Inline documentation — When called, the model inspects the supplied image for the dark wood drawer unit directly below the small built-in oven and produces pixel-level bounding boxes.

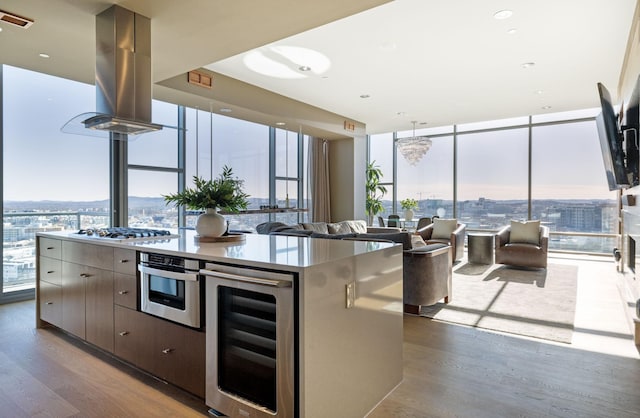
[114,305,205,398]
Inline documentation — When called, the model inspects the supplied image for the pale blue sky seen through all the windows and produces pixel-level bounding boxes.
[3,62,615,201]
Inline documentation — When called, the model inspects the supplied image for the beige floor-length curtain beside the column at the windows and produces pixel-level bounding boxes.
[307,137,331,222]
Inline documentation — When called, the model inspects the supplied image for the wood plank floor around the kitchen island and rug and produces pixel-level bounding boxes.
[0,256,640,418]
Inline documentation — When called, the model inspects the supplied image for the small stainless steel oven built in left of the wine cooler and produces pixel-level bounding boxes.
[138,253,204,329]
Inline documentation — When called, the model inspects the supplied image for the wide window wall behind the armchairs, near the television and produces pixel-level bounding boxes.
[369,109,618,253]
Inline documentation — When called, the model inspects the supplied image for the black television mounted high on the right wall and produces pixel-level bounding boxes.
[596,83,638,190]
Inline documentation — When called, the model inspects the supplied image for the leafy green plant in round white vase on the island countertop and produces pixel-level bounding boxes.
[163,165,249,237]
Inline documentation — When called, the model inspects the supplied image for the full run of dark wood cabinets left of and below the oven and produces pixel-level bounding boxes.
[37,237,206,398]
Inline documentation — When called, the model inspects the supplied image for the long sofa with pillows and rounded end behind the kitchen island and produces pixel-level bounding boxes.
[256,221,453,315]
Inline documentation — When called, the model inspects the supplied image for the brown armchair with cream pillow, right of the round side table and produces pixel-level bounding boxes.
[495,223,549,268]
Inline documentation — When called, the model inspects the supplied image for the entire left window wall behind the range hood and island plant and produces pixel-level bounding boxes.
[0,66,310,303]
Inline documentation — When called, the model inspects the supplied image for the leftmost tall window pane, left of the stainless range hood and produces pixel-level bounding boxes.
[0,65,109,300]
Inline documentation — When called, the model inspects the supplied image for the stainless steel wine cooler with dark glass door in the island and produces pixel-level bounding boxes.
[201,263,296,418]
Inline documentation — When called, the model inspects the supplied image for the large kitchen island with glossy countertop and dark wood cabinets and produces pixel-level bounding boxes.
[37,230,402,417]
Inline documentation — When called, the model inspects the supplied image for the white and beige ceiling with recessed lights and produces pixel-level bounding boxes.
[0,0,636,134]
